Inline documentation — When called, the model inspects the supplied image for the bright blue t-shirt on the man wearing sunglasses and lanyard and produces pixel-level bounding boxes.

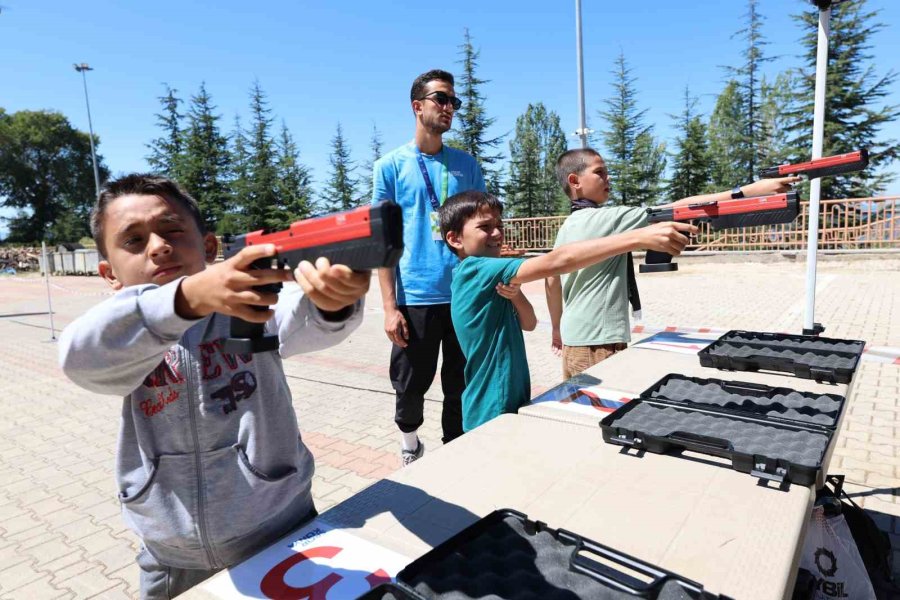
[372,142,485,306]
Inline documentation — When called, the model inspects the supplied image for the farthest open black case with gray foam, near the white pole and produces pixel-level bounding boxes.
[697,330,866,383]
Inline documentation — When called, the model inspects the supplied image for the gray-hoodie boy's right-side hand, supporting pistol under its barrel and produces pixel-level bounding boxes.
[294,257,372,312]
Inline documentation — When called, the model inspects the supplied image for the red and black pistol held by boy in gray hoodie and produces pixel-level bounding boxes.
[223,202,403,354]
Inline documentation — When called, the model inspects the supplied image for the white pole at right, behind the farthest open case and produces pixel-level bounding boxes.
[803,8,831,335]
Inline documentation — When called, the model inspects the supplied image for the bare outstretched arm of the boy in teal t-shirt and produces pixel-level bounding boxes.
[510,223,697,283]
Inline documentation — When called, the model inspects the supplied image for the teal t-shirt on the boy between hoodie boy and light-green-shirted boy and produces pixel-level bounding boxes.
[450,256,531,431]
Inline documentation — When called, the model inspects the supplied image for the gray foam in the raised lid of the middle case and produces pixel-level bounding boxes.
[651,378,841,427]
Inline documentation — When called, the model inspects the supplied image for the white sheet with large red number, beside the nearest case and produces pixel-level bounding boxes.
[202,519,410,600]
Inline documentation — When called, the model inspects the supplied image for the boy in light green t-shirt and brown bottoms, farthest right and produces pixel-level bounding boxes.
[545,148,800,379]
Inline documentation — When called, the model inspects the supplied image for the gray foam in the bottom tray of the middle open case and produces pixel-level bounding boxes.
[610,402,828,467]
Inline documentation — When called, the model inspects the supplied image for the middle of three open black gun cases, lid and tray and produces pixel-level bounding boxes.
[600,374,846,485]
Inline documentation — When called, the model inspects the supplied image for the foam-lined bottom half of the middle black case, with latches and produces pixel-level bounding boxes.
[600,398,836,485]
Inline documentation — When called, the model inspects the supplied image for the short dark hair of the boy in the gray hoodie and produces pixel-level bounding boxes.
[91,173,206,258]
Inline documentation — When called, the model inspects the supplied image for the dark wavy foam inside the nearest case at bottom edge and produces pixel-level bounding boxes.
[405,516,697,600]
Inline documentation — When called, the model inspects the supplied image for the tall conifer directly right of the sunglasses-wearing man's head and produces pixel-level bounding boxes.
[447,29,503,195]
